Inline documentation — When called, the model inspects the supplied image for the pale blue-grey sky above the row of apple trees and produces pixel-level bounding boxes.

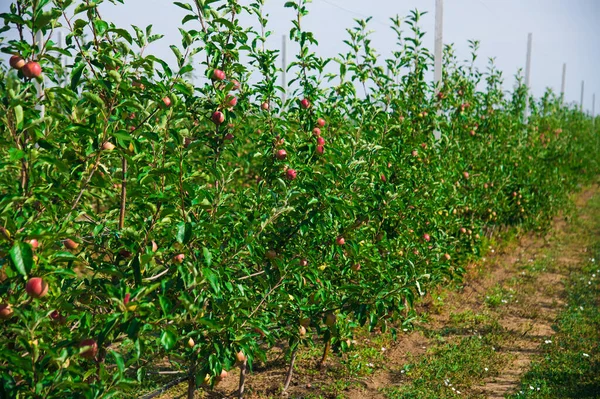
[0,0,600,114]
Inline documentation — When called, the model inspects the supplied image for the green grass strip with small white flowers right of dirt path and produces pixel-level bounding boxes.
[509,246,600,399]
